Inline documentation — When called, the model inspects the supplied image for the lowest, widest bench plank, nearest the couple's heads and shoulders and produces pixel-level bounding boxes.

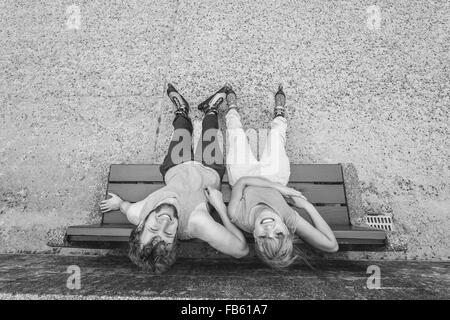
[67,224,386,244]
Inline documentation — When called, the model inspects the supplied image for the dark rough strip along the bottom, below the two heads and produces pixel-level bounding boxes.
[0,255,450,299]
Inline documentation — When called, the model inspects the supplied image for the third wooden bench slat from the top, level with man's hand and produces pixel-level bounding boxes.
[103,206,349,225]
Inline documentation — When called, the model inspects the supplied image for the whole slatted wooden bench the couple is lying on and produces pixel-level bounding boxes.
[65,164,386,248]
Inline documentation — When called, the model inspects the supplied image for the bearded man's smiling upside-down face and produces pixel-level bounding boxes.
[141,208,178,244]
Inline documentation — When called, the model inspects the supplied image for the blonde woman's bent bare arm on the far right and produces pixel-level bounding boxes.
[292,197,339,252]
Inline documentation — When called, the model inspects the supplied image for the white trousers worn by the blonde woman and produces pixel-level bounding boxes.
[225,108,291,186]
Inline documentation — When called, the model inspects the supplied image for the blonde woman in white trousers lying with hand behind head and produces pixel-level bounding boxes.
[226,85,338,269]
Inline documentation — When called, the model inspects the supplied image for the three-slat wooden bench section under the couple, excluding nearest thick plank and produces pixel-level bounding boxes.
[102,164,350,225]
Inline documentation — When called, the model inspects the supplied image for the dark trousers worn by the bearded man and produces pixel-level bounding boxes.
[159,113,225,180]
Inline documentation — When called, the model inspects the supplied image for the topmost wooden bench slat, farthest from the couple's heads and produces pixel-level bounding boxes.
[109,164,343,183]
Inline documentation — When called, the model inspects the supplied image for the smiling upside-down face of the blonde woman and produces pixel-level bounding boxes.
[253,209,289,238]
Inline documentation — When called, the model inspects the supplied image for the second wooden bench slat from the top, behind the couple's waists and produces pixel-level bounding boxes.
[108,183,346,204]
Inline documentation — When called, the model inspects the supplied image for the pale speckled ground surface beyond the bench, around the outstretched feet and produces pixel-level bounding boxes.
[0,0,450,259]
